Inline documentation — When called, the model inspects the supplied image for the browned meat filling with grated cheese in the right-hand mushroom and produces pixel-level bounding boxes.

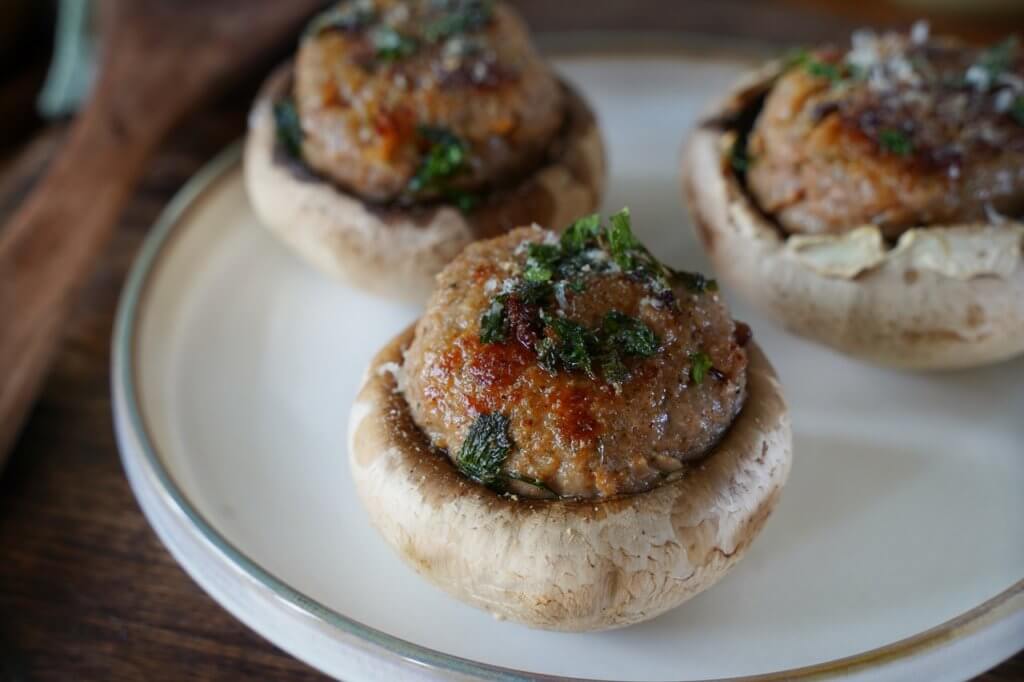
[746,25,1024,238]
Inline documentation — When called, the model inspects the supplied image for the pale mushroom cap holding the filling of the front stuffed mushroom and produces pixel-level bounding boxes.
[349,328,792,632]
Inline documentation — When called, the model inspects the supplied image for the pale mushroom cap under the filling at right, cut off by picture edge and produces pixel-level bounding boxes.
[682,63,1024,370]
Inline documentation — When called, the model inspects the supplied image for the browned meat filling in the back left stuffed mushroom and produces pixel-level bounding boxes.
[279,0,563,203]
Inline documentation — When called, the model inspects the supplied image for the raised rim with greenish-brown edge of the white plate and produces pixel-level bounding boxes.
[111,54,1024,682]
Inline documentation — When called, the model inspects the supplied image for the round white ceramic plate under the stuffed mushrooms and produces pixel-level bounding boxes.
[114,50,1024,680]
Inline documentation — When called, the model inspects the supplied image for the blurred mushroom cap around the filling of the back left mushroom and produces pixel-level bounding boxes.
[244,62,605,302]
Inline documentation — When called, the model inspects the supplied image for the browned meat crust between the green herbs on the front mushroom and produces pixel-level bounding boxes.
[404,227,749,498]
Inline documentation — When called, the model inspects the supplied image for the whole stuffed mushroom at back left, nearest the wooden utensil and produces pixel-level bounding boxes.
[245,0,604,299]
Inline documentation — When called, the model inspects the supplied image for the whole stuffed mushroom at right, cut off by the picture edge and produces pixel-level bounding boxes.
[683,24,1024,369]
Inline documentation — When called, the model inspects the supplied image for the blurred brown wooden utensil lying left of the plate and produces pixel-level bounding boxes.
[0,0,318,465]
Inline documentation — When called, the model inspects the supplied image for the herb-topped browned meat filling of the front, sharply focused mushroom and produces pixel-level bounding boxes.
[404,211,750,498]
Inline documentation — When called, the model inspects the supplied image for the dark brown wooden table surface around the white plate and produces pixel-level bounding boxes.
[0,0,1024,682]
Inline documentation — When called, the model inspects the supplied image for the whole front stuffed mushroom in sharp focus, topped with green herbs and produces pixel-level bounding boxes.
[349,211,792,631]
